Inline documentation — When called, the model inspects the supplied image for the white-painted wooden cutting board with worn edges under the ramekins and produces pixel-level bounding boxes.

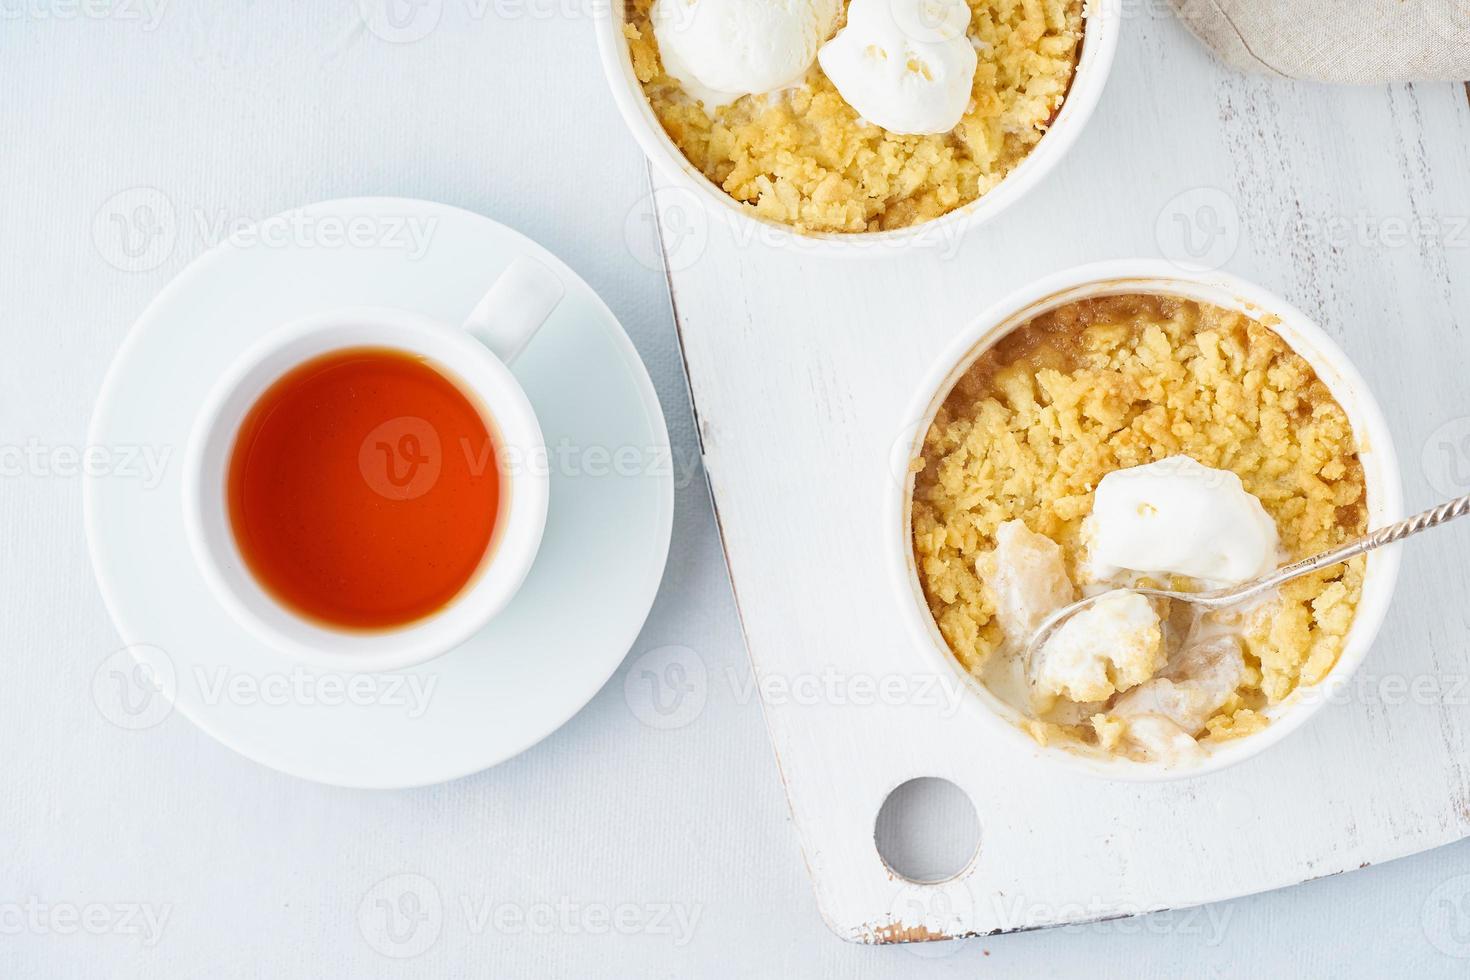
[654,3,1470,942]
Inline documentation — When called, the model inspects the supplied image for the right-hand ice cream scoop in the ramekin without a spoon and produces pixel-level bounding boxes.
[817,0,979,134]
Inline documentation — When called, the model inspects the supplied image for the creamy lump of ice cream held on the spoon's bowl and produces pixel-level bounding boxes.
[1028,591,1169,713]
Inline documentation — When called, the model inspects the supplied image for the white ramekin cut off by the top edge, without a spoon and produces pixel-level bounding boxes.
[592,0,1123,256]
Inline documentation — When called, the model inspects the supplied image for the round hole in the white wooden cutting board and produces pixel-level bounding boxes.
[873,776,980,884]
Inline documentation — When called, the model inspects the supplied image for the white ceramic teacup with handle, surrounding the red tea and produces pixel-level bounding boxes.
[182,257,564,671]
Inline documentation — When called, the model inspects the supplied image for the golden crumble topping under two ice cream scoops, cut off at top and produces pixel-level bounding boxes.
[623,0,1082,232]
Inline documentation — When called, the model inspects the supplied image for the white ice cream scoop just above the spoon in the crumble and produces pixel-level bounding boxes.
[1085,455,1280,585]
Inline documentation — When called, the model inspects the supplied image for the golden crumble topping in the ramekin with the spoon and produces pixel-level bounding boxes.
[913,295,1367,739]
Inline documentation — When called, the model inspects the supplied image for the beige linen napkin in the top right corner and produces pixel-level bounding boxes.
[1173,0,1470,84]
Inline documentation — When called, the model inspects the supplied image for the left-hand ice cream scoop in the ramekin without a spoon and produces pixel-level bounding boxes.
[650,0,841,109]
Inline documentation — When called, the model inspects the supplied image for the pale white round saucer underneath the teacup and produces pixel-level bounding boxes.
[84,198,673,788]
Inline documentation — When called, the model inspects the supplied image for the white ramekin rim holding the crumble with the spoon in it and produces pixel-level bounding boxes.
[885,259,1402,782]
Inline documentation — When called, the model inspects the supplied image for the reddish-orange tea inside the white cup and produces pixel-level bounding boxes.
[226,348,503,629]
